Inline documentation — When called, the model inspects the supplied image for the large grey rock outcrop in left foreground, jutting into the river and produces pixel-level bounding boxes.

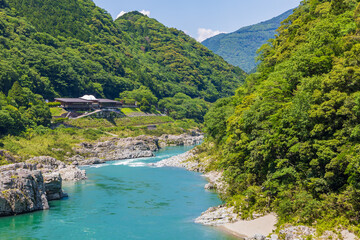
[0,157,86,216]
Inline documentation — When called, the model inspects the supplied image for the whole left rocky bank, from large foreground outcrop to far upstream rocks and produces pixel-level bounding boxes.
[0,133,203,217]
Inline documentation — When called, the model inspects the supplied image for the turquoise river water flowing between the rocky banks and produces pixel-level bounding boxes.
[0,147,238,240]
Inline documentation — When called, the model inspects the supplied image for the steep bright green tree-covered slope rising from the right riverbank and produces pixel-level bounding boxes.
[206,0,360,232]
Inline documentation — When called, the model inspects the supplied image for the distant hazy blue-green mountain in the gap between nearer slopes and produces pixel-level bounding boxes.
[202,9,293,72]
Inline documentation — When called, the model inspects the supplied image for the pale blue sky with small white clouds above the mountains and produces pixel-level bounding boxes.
[94,0,301,41]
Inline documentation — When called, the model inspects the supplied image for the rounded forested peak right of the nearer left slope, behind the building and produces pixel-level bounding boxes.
[116,12,244,101]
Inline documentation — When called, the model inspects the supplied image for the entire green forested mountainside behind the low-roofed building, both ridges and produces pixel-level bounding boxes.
[0,0,244,101]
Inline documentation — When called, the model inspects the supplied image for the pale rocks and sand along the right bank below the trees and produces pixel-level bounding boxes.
[153,150,358,240]
